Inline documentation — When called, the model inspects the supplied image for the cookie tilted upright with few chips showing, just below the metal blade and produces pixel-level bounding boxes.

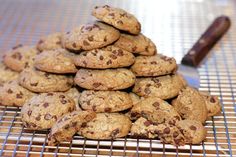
[172,86,207,123]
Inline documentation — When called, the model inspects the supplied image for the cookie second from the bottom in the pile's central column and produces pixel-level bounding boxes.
[79,90,133,112]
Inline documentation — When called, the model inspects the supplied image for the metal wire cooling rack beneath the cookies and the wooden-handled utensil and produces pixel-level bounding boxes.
[0,0,236,157]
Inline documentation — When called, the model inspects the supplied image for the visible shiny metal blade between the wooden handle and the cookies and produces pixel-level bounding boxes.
[178,64,200,89]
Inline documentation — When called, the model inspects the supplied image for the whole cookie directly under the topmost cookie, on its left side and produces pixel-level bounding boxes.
[62,22,120,51]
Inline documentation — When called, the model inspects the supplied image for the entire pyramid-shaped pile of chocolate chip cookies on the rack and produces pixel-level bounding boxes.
[0,5,221,146]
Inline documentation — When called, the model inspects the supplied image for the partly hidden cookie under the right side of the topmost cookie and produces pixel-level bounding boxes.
[114,33,157,56]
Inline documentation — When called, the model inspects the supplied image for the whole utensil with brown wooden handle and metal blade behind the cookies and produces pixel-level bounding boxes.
[178,15,231,88]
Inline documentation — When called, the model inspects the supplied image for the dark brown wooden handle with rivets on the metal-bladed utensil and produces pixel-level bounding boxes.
[181,16,231,67]
